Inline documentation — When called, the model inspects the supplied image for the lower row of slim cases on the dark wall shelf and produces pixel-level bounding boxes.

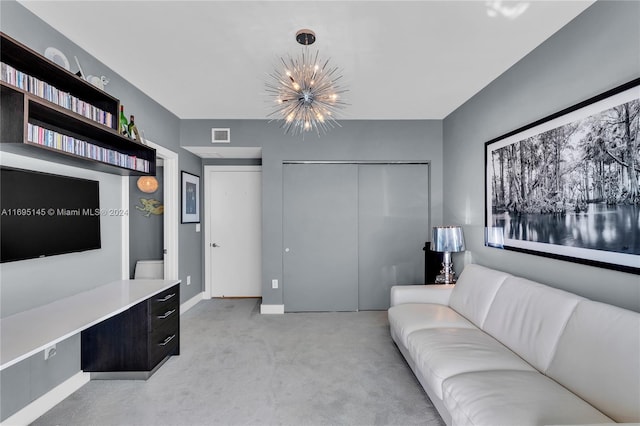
[27,123,149,173]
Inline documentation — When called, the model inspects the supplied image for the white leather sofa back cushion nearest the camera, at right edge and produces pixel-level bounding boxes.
[547,301,640,423]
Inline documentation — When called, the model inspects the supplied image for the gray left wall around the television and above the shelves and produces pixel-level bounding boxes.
[0,0,203,420]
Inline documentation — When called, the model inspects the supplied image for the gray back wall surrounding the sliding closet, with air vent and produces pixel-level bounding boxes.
[180,120,443,305]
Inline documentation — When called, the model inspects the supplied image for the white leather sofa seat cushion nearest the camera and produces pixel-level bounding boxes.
[443,370,612,426]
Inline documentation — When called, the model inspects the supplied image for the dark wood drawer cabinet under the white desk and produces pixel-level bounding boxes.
[81,285,180,379]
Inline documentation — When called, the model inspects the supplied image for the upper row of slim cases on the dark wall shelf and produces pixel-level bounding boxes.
[0,62,114,128]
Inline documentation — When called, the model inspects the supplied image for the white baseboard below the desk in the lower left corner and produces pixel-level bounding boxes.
[0,371,90,426]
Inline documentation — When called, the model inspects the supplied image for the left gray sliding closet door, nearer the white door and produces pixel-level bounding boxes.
[282,164,358,312]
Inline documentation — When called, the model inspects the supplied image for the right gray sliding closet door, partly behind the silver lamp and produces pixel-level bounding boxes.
[358,164,429,310]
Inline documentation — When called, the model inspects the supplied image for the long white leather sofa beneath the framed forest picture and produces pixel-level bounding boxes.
[388,265,640,426]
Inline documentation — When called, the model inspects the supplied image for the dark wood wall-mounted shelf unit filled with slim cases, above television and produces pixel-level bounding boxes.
[0,32,156,176]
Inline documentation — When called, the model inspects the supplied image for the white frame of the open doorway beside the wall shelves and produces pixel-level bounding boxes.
[122,139,180,280]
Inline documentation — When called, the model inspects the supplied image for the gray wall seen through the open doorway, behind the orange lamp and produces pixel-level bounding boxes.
[129,167,164,278]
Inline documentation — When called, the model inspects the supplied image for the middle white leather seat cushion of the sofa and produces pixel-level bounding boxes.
[407,328,536,399]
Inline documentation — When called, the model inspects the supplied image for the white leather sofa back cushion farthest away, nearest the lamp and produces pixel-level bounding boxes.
[449,264,511,328]
